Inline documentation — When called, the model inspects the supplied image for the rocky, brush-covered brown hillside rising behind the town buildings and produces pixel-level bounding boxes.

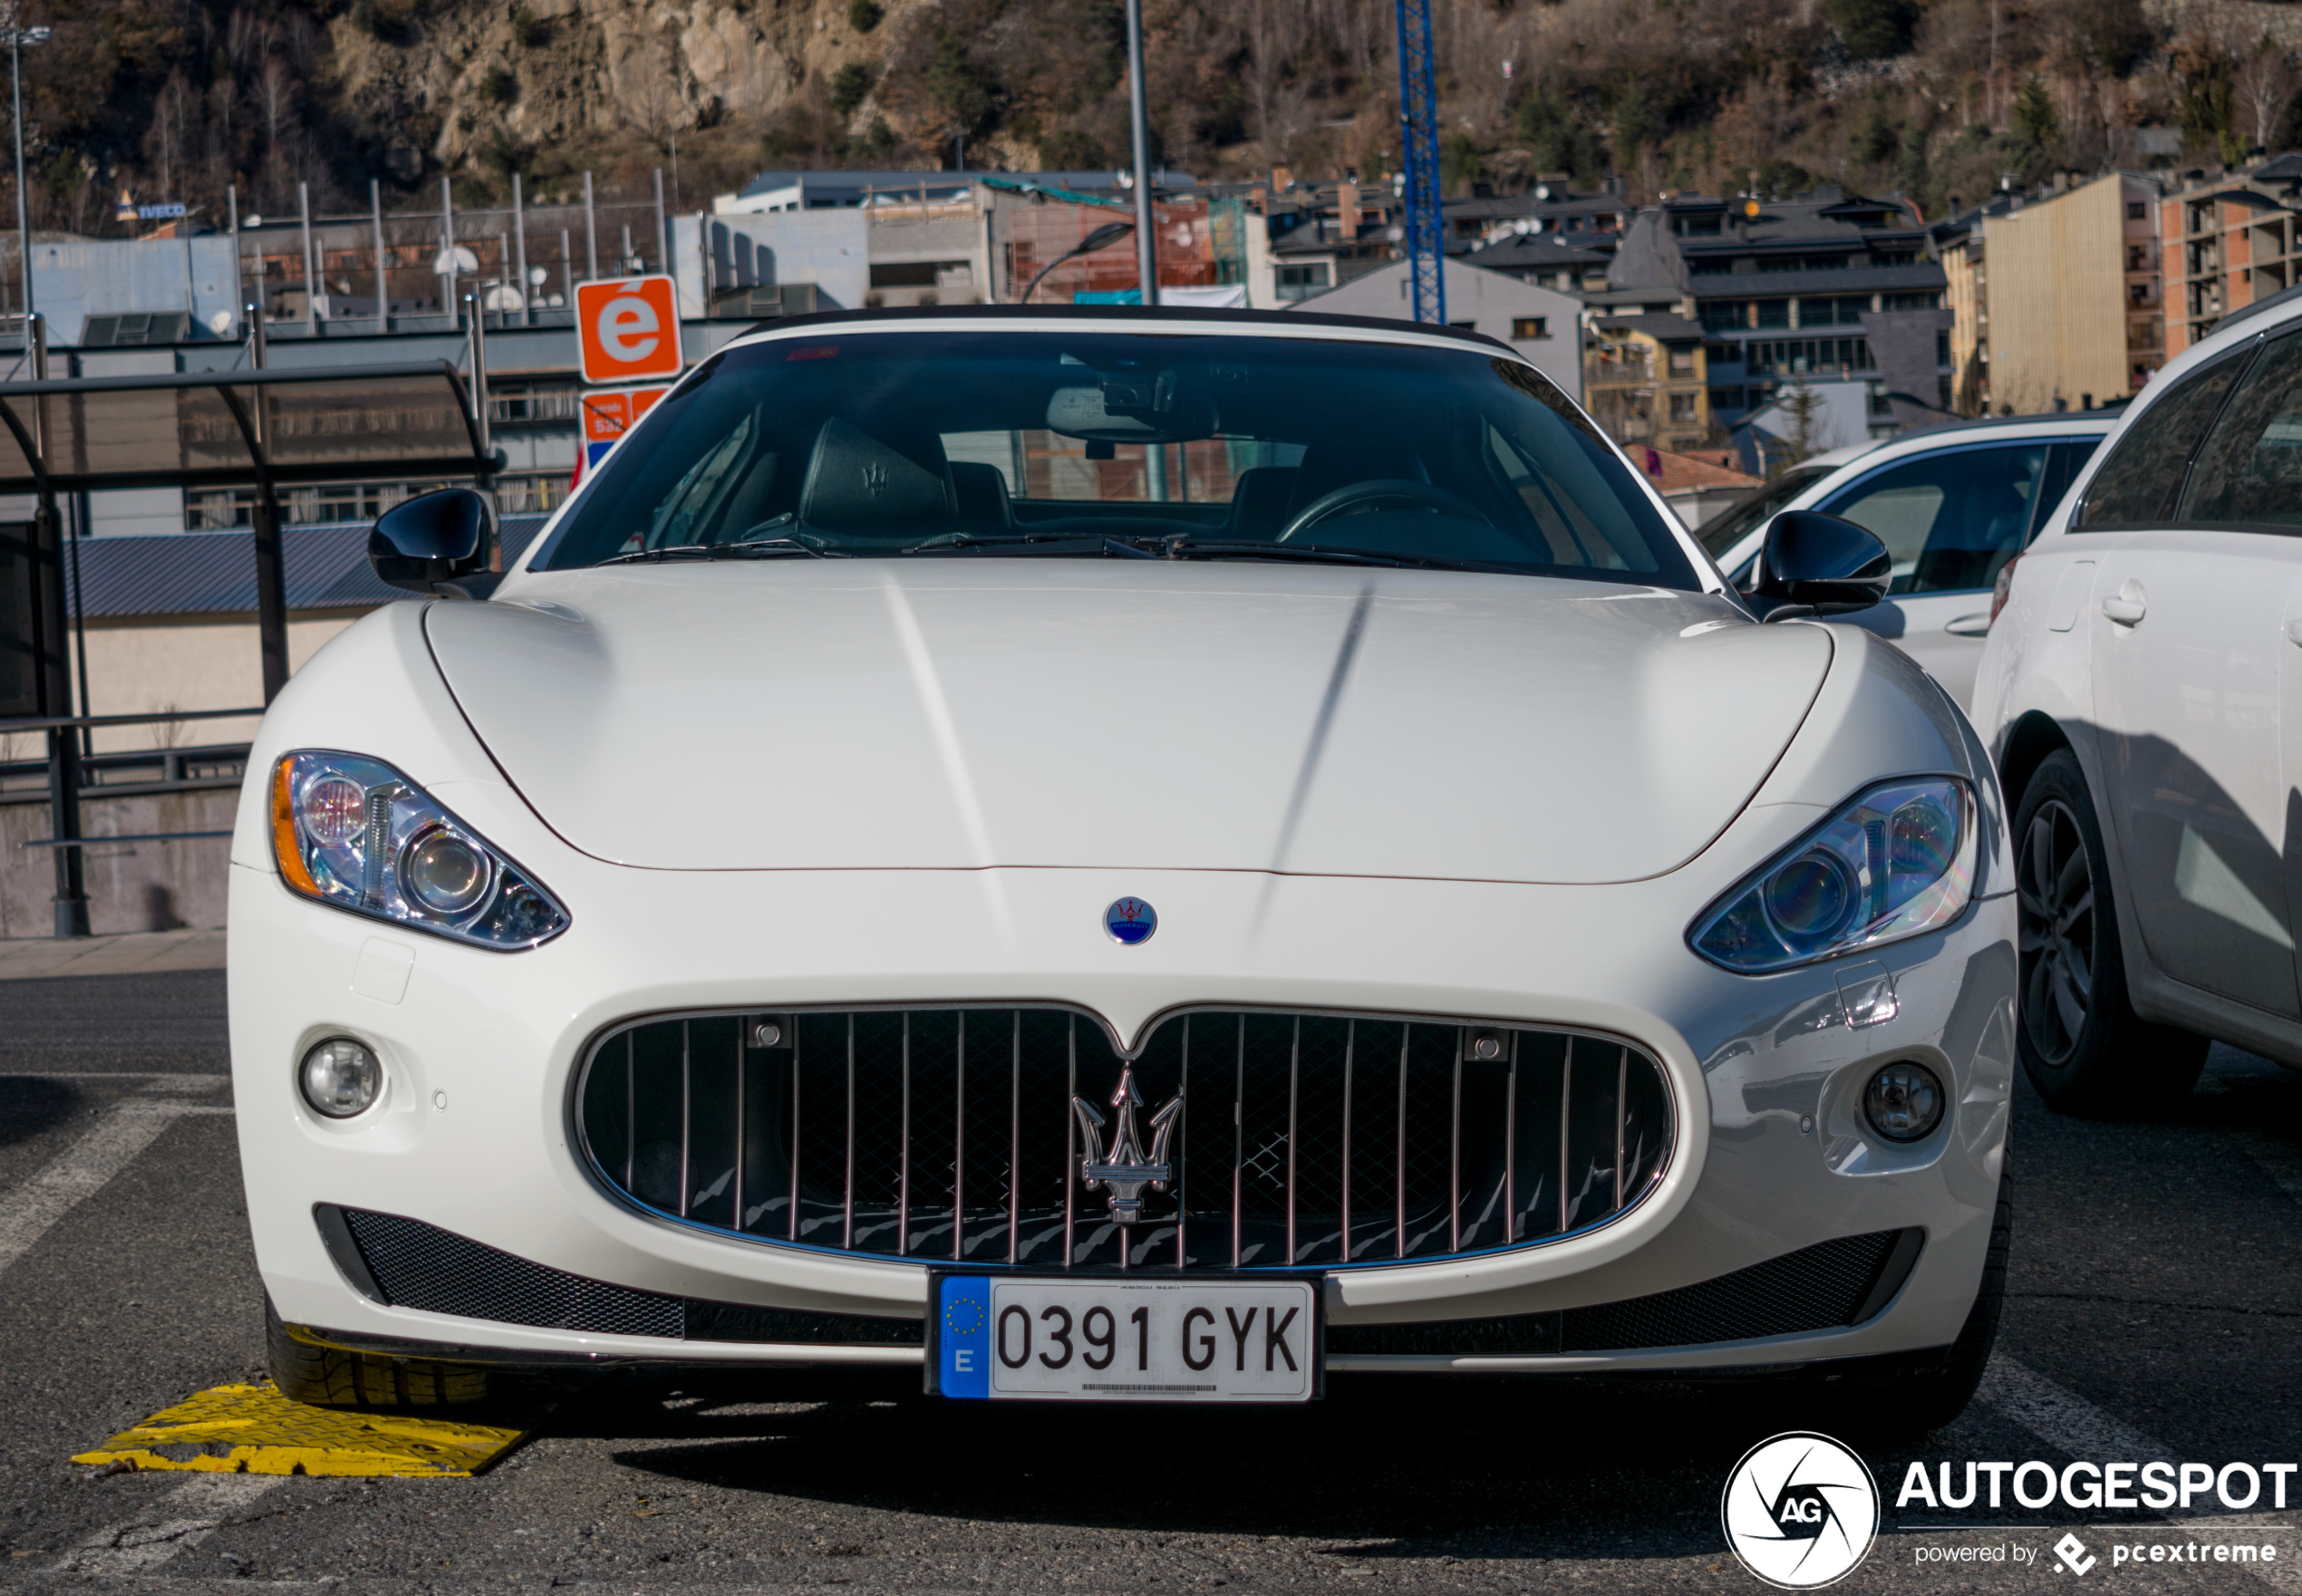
[25,0,2302,233]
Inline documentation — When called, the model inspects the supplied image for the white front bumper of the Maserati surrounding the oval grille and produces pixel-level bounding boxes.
[230,801,2015,1373]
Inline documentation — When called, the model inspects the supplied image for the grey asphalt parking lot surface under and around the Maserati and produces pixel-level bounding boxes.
[0,970,2302,1593]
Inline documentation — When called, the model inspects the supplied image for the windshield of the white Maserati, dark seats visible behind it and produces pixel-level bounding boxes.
[538,327,1699,590]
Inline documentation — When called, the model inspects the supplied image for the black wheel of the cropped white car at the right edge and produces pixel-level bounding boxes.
[2015,749,2210,1119]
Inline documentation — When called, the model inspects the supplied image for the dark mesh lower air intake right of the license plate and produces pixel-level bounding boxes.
[1326,1230,1918,1357]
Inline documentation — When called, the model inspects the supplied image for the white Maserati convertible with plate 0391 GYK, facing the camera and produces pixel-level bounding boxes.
[230,309,2017,1426]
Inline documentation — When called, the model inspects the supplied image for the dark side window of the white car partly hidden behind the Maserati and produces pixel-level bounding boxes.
[1819,444,2046,592]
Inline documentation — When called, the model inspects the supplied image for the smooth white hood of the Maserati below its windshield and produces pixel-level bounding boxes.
[426,557,1833,882]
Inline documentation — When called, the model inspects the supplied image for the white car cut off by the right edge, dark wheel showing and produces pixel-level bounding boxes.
[1975,290,2302,1115]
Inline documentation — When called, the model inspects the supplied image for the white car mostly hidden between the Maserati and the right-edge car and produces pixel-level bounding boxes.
[1697,410,2118,707]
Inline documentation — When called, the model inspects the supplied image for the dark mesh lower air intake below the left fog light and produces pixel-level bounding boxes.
[343,1209,686,1336]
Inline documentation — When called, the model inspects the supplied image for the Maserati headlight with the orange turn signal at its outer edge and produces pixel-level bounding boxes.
[272,750,568,949]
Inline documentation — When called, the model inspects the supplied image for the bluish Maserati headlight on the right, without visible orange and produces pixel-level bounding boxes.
[1688,776,1975,974]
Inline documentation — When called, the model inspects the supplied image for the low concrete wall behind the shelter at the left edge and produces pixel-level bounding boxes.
[0,788,239,937]
